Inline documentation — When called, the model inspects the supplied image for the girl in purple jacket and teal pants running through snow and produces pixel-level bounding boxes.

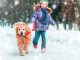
[31,1,55,53]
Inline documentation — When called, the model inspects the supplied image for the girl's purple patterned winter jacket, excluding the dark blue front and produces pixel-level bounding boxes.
[31,10,55,31]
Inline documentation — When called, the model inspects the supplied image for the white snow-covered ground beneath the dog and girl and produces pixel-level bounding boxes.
[0,26,80,60]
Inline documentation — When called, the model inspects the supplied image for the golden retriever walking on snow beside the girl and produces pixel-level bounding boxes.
[16,22,31,56]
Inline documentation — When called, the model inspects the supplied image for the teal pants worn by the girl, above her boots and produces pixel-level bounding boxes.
[33,31,46,48]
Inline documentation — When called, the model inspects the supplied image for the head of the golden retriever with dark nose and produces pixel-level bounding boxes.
[16,22,28,36]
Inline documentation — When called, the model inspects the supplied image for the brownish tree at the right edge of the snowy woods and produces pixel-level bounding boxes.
[62,0,75,29]
